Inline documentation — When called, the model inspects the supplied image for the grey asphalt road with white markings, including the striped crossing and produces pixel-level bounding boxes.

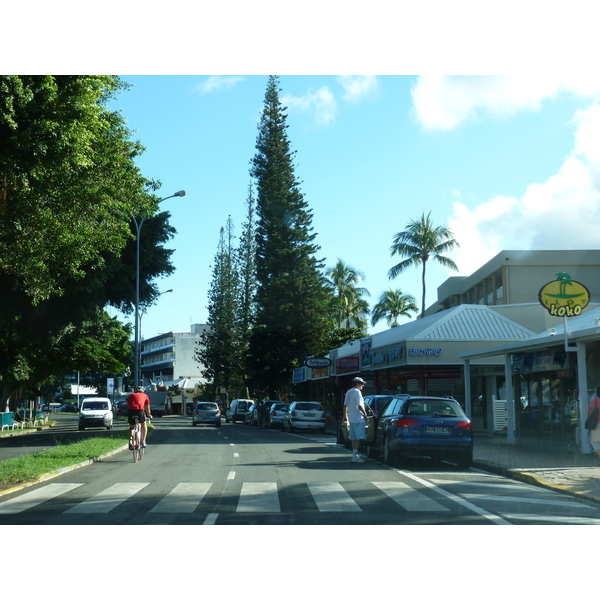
[0,418,600,525]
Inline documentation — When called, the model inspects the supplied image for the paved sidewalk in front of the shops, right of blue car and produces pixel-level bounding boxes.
[473,434,600,503]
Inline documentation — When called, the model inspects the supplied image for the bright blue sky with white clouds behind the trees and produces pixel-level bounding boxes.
[103,74,600,337]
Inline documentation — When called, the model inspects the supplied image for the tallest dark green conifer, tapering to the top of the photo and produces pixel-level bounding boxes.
[248,76,327,397]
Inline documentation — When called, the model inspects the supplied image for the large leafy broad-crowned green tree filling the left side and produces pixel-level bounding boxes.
[0,76,173,410]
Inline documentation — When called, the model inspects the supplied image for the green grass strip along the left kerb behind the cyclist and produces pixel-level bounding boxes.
[0,430,129,485]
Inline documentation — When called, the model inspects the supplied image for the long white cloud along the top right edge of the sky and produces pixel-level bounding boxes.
[411,73,600,130]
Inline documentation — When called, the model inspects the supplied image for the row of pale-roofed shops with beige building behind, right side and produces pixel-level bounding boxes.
[294,250,600,448]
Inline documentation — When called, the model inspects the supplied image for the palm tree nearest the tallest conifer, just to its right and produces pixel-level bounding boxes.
[325,258,371,327]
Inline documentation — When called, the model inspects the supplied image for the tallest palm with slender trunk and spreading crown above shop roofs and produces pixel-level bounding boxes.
[388,213,459,317]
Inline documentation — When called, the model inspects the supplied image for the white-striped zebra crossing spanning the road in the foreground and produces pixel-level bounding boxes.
[0,472,600,525]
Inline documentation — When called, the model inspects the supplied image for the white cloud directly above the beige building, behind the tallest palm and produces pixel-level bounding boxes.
[449,104,600,275]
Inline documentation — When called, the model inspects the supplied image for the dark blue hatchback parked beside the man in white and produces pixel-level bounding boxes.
[369,396,473,468]
